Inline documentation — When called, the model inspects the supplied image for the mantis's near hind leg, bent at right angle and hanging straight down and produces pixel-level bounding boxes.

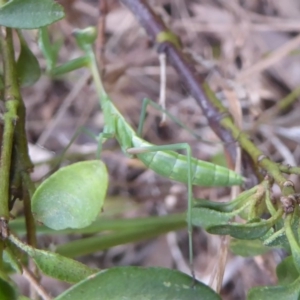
[127,143,195,278]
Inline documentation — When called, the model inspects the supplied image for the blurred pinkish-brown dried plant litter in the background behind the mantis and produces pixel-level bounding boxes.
[23,0,300,300]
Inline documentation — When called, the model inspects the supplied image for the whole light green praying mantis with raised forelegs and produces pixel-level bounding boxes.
[40,27,244,273]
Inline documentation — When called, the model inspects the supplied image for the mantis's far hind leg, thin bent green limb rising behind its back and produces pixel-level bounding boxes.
[137,98,206,143]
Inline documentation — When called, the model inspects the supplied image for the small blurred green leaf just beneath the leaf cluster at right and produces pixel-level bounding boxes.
[230,239,271,257]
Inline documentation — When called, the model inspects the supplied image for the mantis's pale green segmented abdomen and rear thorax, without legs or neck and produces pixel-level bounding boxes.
[100,94,243,186]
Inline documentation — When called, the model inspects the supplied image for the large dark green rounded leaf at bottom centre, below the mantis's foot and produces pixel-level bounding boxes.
[55,267,221,300]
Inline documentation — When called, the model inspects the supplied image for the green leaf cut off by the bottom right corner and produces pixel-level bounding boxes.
[247,278,300,300]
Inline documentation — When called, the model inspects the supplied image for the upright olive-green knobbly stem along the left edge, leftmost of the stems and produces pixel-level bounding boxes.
[0,27,20,220]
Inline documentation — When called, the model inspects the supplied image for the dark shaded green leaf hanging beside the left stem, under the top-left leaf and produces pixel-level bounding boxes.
[17,31,41,86]
